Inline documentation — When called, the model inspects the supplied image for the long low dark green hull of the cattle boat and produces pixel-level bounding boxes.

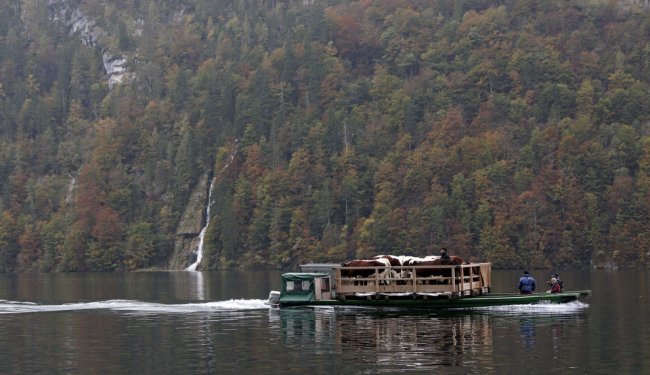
[279,290,591,310]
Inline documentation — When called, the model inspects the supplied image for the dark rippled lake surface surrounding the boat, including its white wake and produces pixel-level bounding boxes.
[0,270,650,374]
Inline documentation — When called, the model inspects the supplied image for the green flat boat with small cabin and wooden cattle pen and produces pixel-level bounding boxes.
[268,263,591,309]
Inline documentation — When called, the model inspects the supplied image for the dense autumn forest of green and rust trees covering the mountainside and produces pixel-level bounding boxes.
[0,0,650,272]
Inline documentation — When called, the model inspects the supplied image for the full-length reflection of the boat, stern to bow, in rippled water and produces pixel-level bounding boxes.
[269,306,584,372]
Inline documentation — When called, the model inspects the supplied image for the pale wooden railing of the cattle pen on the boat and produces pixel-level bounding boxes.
[335,263,491,296]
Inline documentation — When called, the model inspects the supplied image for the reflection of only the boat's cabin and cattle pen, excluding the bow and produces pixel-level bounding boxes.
[269,309,493,369]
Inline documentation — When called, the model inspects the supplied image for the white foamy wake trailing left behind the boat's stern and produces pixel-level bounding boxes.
[0,299,269,314]
